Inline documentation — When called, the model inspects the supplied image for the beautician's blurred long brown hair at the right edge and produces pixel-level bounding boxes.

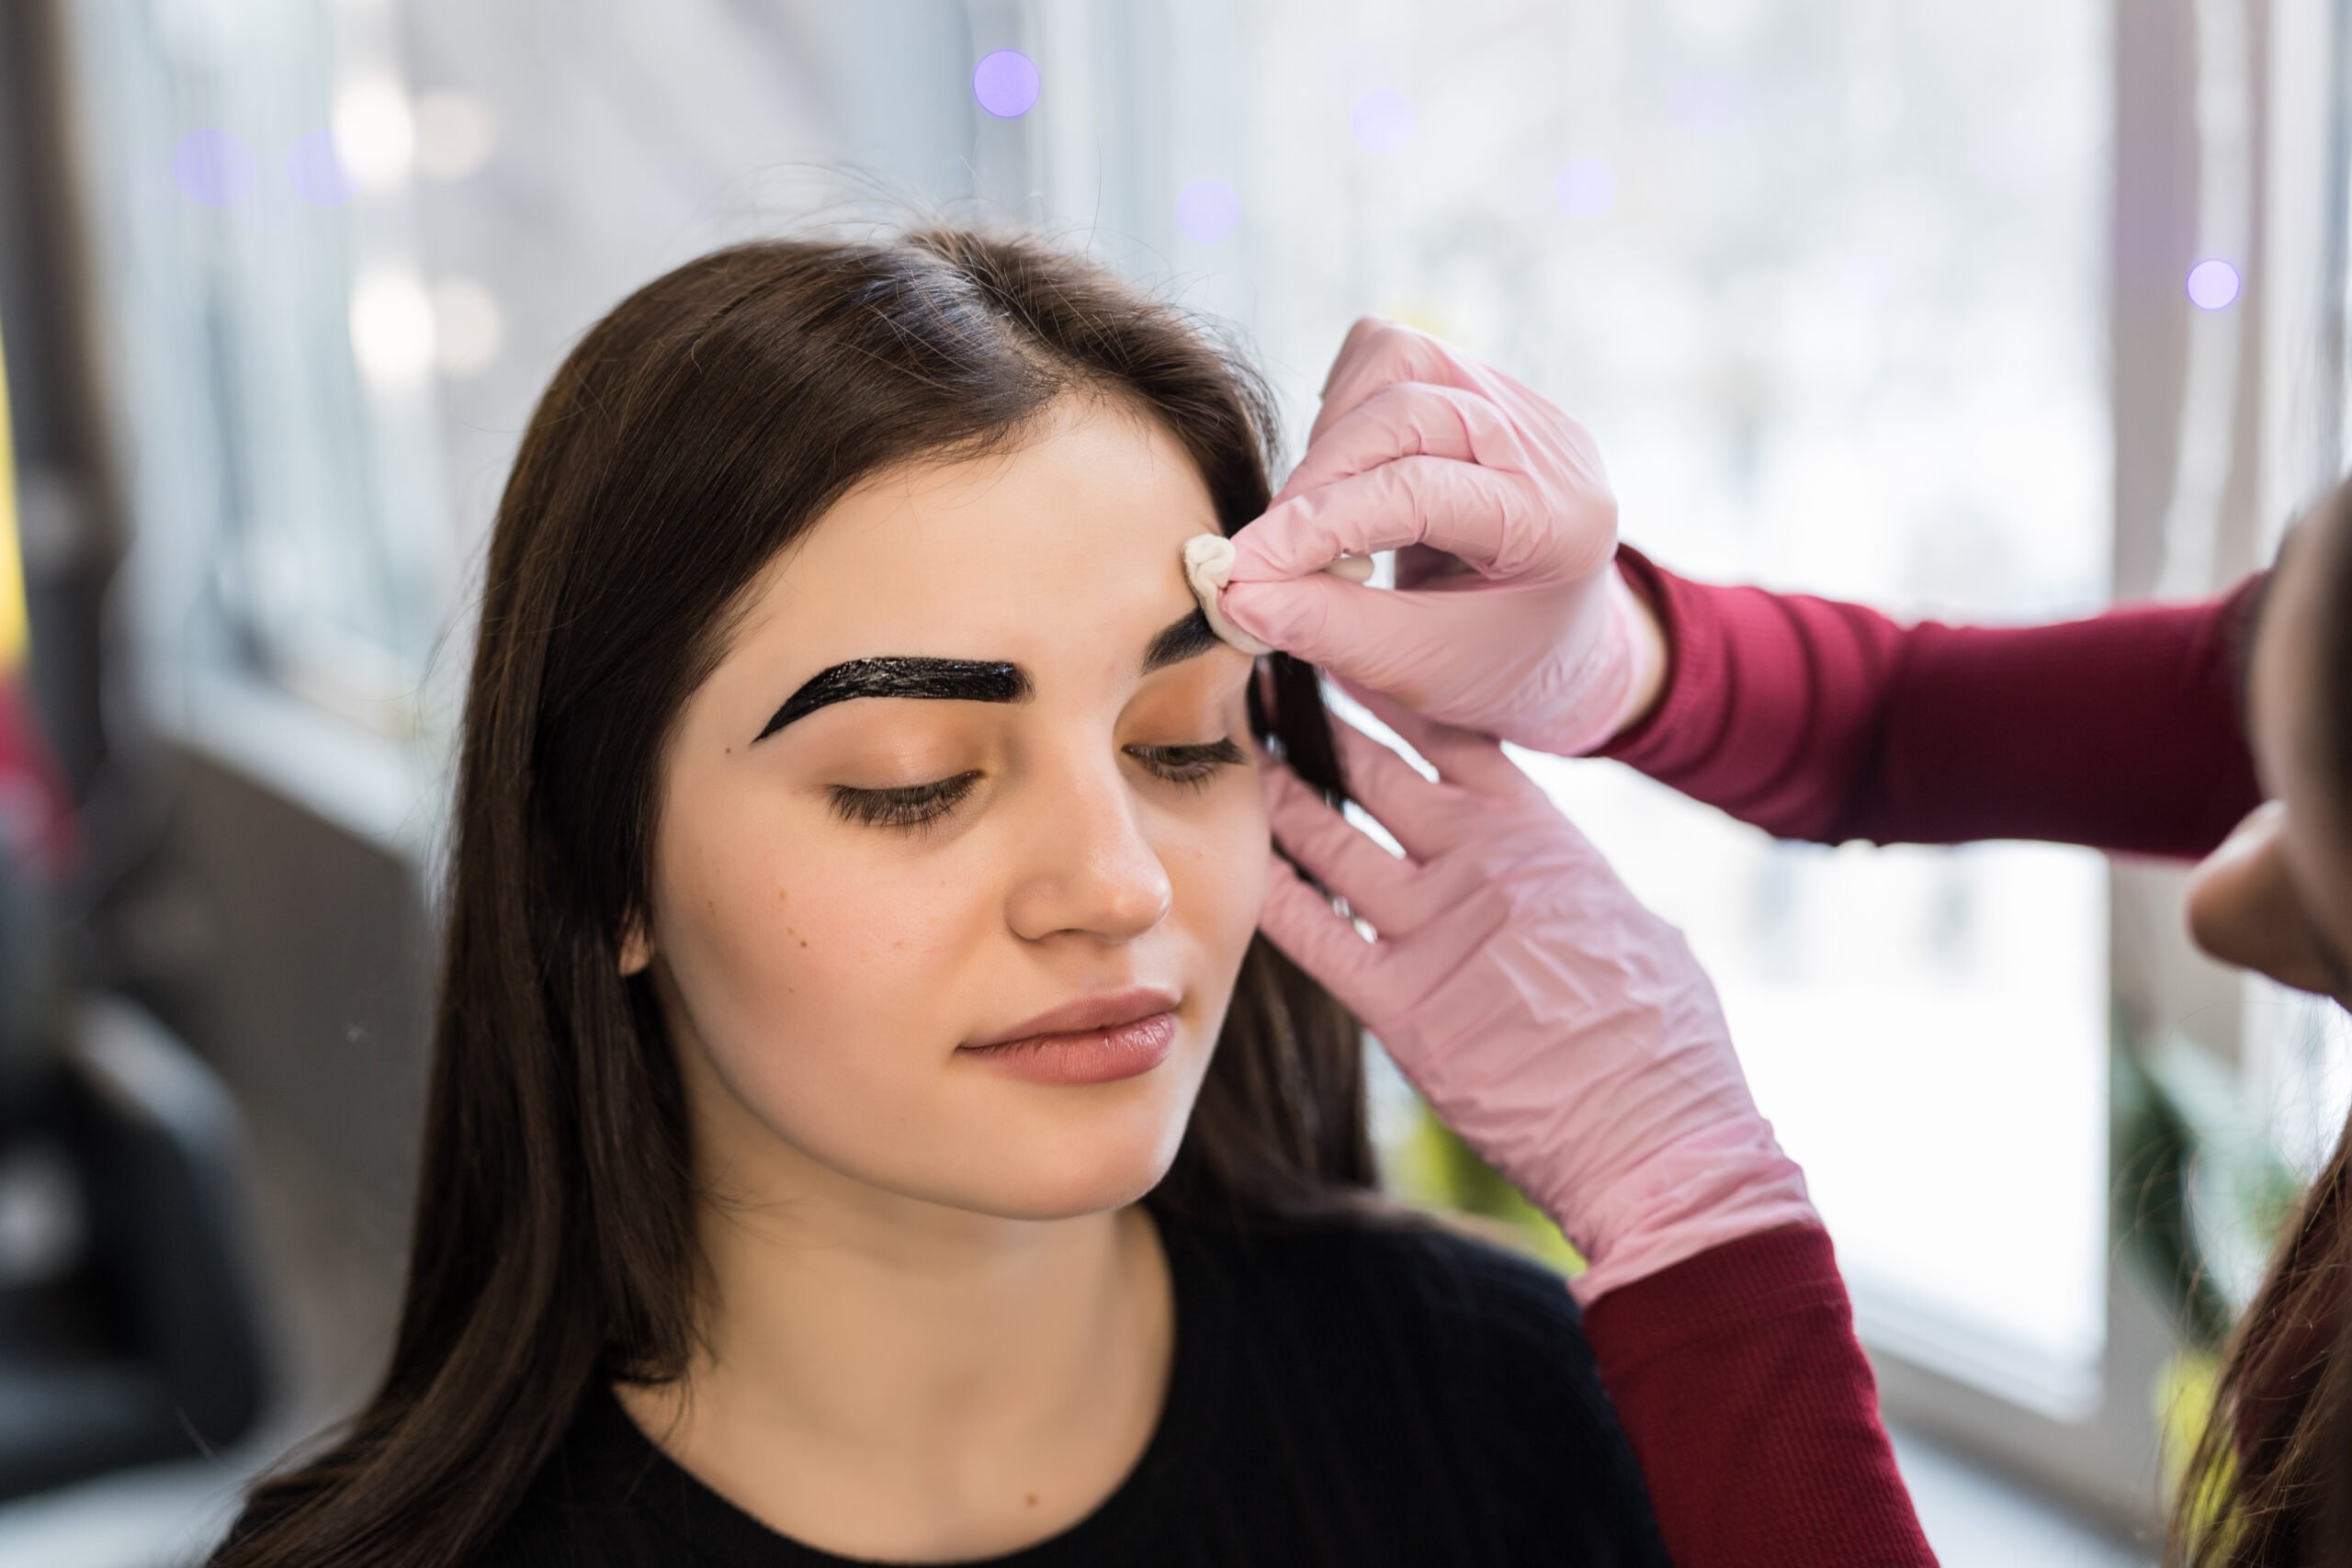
[2166,484,2352,1568]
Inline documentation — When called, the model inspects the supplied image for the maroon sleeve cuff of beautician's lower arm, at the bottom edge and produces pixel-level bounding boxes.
[1585,1224,1936,1568]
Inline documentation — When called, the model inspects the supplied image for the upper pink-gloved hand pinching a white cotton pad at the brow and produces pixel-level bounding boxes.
[1221,317,1663,757]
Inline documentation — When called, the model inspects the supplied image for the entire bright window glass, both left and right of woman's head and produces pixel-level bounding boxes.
[73,0,2173,1448]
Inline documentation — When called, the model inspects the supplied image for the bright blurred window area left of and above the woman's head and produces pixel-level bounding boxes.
[66,0,997,844]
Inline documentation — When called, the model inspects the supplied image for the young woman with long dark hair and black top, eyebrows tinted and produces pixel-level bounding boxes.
[217,232,1665,1568]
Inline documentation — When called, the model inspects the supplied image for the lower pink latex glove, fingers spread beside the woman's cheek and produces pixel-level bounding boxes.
[1259,691,1820,1303]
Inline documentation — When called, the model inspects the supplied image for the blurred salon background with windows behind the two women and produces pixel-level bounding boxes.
[0,0,2352,1565]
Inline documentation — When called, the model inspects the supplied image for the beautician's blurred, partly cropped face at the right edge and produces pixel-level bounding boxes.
[2188,505,2352,1004]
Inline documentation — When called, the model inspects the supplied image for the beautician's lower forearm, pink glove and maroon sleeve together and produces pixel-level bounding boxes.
[1261,691,1933,1568]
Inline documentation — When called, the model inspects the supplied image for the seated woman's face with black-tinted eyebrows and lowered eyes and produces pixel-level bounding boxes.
[623,400,1268,1218]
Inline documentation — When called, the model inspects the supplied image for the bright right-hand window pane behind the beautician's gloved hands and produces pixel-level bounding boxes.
[1148,0,2109,1413]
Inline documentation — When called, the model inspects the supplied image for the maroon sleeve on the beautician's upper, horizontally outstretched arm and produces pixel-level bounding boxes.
[1601,550,2260,858]
